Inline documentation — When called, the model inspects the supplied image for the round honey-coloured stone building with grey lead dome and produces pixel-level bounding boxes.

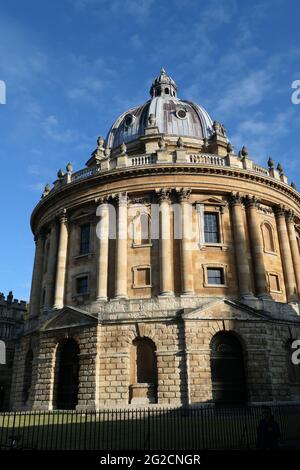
[11,70,300,410]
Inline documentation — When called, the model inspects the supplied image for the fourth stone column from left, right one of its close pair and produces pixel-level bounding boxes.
[115,193,128,299]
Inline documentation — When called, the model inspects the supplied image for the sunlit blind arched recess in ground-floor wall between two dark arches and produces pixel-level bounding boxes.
[129,337,157,404]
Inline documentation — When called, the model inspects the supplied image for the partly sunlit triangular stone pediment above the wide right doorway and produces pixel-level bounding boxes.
[182,299,271,321]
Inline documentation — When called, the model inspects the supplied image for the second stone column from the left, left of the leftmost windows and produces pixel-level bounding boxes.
[53,210,68,309]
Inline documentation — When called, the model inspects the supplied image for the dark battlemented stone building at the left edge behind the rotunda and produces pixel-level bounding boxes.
[0,292,27,411]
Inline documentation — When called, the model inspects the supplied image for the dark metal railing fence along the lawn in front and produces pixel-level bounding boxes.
[0,405,300,450]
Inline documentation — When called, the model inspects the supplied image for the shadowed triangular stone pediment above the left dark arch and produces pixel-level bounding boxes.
[41,306,98,331]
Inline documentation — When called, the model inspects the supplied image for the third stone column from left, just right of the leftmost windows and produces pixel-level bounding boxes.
[96,198,109,301]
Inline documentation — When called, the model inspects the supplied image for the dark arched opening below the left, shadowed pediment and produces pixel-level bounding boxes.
[56,339,79,410]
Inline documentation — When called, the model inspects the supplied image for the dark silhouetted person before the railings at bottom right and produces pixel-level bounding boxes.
[256,406,280,450]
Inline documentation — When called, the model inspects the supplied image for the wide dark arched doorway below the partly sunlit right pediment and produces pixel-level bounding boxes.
[211,332,247,404]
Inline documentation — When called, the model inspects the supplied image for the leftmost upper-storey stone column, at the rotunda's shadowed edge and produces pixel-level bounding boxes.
[30,231,45,317]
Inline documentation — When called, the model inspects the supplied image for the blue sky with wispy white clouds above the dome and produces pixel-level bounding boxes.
[0,0,300,299]
